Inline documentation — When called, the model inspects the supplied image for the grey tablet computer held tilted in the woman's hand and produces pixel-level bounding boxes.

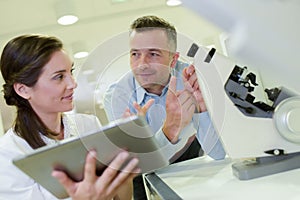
[13,116,169,198]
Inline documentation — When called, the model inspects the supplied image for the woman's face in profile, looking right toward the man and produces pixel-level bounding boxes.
[28,50,77,115]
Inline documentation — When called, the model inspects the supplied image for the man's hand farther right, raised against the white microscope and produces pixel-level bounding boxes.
[182,65,207,112]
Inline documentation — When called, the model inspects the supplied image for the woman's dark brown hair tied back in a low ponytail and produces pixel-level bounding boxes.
[0,35,63,149]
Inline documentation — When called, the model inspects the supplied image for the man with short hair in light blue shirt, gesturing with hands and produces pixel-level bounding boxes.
[104,16,225,198]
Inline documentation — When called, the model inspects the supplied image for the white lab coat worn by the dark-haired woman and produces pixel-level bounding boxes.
[0,114,101,200]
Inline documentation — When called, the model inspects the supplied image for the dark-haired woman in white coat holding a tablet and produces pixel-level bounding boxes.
[0,35,140,200]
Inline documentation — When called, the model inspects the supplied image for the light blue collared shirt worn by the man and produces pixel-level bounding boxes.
[104,62,225,159]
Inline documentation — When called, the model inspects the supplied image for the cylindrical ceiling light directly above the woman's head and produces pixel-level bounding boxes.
[55,0,78,25]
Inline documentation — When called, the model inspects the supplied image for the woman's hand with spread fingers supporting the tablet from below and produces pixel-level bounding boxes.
[52,151,141,200]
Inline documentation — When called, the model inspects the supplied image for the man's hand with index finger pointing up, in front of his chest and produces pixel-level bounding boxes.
[162,76,196,143]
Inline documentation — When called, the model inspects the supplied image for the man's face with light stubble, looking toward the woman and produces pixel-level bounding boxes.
[129,29,177,95]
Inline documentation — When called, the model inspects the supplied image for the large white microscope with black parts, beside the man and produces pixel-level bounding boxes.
[183,0,300,180]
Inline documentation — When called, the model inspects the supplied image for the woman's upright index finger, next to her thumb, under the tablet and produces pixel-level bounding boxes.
[84,150,97,183]
